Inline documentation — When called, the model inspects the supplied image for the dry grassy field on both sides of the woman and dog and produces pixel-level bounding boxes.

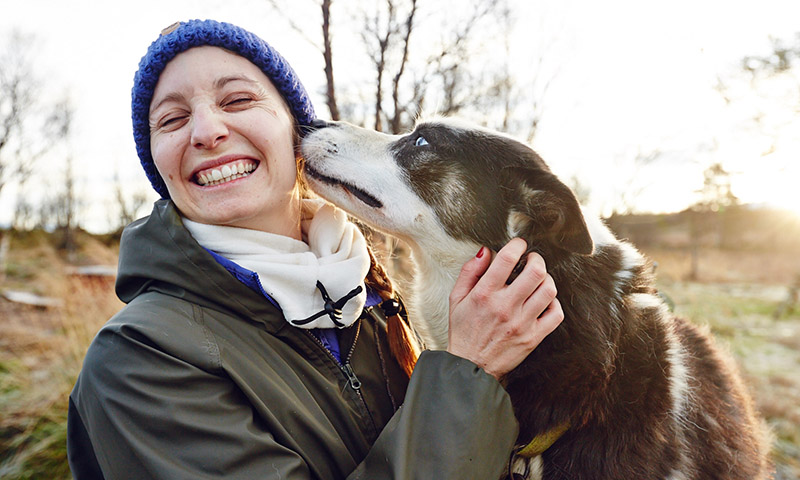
[0,231,800,480]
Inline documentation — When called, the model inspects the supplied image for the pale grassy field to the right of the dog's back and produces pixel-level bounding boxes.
[647,251,800,480]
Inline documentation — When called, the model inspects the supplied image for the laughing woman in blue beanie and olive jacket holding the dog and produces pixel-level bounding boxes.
[68,21,563,480]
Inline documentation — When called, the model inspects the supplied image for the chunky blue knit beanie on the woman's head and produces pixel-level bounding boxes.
[131,20,314,198]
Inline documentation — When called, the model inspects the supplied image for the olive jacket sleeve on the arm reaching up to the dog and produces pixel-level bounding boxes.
[348,351,518,480]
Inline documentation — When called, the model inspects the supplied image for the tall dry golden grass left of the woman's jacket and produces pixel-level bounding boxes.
[0,231,121,479]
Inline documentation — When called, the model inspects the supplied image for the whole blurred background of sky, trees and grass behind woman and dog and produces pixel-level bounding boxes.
[0,0,800,479]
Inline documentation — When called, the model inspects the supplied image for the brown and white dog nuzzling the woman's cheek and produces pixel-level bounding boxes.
[301,119,770,480]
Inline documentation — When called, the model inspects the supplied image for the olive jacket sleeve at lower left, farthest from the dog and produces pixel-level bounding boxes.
[67,316,311,480]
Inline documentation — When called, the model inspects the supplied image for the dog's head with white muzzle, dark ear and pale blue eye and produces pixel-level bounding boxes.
[302,119,593,260]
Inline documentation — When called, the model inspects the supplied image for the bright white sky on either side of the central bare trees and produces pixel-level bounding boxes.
[0,0,800,232]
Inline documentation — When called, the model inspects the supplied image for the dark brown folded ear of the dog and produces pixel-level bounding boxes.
[508,171,594,255]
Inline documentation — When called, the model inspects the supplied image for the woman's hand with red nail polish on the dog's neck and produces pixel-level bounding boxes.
[447,238,564,380]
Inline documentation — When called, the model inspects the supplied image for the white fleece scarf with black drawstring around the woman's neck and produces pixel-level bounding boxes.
[183,199,370,329]
